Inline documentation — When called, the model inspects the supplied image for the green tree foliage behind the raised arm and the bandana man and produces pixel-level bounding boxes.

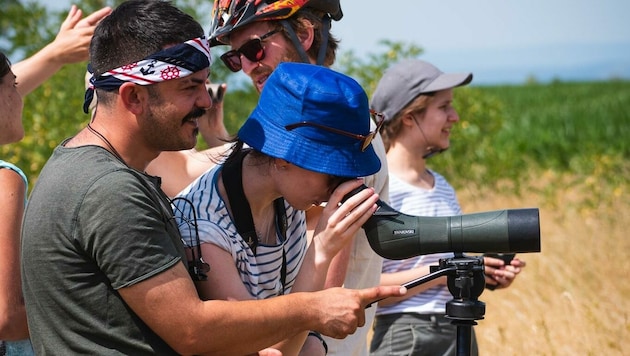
[0,0,220,187]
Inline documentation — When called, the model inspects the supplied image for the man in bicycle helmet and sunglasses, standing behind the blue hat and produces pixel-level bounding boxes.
[209,0,389,356]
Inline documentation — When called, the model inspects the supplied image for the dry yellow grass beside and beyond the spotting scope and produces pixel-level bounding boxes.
[458,175,630,355]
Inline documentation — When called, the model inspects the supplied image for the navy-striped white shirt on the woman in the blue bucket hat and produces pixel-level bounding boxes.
[173,165,307,299]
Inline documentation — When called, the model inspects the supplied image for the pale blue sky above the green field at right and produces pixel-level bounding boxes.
[333,0,630,84]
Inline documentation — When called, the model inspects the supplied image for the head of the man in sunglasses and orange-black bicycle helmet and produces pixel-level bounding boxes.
[210,0,343,92]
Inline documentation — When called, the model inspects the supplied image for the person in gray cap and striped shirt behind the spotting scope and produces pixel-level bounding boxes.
[370,59,525,355]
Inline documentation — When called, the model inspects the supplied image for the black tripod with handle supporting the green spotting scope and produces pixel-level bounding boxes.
[404,253,486,356]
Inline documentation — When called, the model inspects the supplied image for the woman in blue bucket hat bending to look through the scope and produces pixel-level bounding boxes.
[173,63,383,355]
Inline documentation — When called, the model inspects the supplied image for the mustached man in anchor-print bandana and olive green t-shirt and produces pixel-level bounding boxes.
[22,0,405,355]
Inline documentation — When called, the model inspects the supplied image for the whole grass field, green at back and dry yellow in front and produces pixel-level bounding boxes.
[366,81,630,356]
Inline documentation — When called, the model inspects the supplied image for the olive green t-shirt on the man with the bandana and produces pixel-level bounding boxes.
[22,146,186,355]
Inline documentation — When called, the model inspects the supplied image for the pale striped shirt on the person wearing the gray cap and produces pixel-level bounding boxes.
[376,171,462,315]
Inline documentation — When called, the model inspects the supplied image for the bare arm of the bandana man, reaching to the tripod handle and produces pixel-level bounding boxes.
[123,263,406,355]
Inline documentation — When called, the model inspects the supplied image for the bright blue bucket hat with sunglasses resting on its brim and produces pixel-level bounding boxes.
[238,62,381,178]
